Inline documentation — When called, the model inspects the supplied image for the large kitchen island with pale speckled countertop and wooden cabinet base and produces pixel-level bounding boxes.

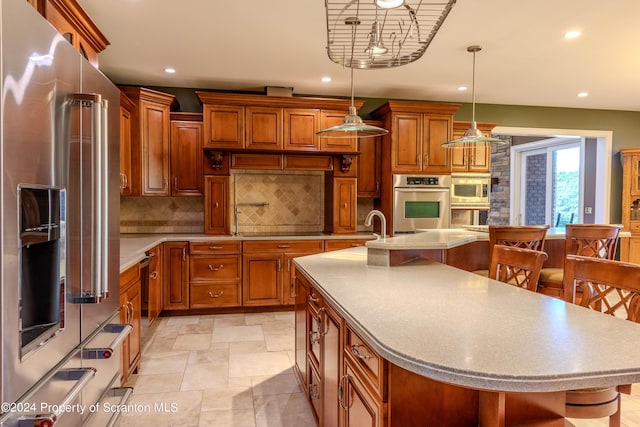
[294,248,640,426]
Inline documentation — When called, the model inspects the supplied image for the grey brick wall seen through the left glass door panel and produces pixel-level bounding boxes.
[525,153,544,225]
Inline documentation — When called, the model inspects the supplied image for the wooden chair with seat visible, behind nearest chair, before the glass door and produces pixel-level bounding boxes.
[538,224,622,296]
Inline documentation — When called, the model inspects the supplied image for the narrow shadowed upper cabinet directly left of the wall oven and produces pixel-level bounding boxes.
[357,133,382,198]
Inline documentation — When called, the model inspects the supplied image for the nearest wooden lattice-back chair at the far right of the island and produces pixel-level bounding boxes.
[563,255,640,427]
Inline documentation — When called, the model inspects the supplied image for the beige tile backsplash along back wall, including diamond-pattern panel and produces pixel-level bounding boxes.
[120,170,373,233]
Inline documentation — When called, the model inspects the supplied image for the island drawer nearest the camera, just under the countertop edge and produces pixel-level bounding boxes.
[344,326,387,401]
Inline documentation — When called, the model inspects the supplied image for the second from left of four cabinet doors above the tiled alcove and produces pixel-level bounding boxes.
[245,106,283,151]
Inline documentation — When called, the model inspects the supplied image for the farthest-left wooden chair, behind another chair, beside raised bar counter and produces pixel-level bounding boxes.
[473,225,549,276]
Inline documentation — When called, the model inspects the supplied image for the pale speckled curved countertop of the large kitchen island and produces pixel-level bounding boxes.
[294,247,640,391]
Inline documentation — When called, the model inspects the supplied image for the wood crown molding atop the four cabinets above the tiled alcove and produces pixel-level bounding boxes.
[196,91,362,111]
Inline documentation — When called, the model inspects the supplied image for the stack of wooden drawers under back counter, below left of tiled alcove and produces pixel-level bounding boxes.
[189,241,242,309]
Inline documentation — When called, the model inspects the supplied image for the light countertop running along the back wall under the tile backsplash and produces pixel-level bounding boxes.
[120,233,374,272]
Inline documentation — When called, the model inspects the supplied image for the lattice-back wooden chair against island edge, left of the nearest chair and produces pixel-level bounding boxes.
[489,245,547,292]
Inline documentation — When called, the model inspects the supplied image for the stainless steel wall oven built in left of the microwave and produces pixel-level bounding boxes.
[393,175,451,235]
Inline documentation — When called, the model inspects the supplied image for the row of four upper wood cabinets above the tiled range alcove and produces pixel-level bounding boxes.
[197,92,363,154]
